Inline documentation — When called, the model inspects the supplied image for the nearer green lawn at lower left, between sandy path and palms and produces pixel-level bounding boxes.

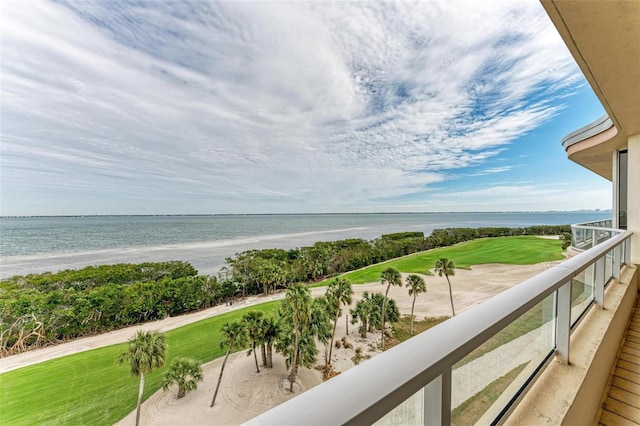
[0,302,279,425]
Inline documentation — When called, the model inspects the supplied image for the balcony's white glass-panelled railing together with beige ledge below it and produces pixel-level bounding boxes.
[249,227,638,425]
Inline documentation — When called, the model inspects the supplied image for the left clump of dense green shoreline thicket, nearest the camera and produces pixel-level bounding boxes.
[0,261,228,356]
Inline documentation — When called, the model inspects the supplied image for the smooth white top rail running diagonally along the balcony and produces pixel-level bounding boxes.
[247,231,632,425]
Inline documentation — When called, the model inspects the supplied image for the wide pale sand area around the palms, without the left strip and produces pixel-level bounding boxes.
[112,262,559,425]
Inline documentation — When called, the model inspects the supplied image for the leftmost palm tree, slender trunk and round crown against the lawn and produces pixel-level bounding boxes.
[118,331,167,426]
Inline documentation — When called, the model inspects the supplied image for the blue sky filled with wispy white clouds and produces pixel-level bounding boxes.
[0,0,611,216]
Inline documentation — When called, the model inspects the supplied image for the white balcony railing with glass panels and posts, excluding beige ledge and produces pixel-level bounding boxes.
[248,227,631,425]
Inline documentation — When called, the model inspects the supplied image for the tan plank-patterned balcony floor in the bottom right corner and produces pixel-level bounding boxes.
[599,302,640,426]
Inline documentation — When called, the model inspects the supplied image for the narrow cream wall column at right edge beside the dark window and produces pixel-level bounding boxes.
[627,133,640,265]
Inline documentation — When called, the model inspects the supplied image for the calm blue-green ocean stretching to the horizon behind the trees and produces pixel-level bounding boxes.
[0,212,611,278]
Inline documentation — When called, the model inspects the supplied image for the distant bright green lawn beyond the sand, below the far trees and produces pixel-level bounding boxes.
[322,236,563,286]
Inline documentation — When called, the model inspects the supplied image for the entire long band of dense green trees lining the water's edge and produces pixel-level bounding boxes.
[0,225,570,356]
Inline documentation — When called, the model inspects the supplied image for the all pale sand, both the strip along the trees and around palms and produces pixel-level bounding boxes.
[0,262,559,425]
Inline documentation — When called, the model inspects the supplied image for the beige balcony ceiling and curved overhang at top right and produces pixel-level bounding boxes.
[541,0,640,180]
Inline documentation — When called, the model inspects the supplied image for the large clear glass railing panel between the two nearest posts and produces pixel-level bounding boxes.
[451,293,555,426]
